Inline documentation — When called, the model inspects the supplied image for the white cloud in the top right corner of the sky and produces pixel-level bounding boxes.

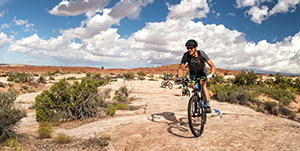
[236,0,300,24]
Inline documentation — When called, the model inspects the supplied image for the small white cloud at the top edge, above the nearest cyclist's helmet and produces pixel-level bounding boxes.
[167,0,209,20]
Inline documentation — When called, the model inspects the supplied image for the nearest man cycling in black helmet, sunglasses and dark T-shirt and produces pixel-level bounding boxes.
[177,39,216,113]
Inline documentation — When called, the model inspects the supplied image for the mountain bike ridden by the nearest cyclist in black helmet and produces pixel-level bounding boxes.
[188,78,207,137]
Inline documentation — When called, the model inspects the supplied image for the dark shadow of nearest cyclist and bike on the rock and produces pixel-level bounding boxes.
[151,112,195,138]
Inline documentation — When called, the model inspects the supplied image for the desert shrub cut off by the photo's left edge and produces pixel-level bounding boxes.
[0,89,26,142]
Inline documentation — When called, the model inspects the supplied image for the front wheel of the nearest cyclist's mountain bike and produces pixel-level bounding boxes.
[188,95,206,137]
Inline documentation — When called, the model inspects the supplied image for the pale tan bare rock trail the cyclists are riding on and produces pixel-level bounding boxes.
[18,80,300,151]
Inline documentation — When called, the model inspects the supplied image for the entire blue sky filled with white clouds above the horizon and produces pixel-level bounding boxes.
[0,0,300,74]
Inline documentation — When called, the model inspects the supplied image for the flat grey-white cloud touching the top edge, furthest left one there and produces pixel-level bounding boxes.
[49,0,109,16]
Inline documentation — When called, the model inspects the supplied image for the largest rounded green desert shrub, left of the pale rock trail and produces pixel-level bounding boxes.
[35,78,105,122]
